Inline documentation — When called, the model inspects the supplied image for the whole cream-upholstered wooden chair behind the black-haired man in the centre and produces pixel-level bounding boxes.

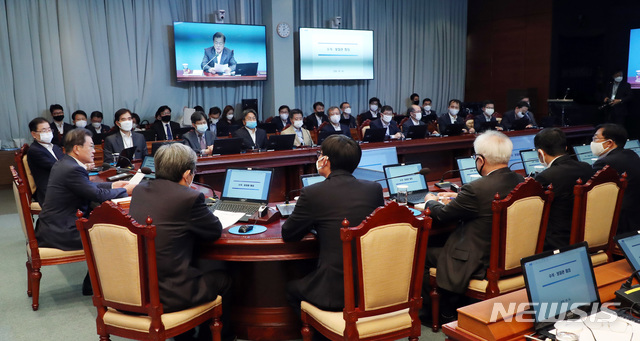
[301,202,431,341]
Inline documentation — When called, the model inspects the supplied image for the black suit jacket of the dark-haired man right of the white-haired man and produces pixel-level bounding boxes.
[536,155,593,250]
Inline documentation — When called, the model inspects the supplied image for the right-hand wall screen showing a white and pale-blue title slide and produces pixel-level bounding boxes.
[300,27,373,80]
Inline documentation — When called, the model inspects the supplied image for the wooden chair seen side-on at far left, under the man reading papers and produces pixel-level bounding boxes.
[9,166,84,310]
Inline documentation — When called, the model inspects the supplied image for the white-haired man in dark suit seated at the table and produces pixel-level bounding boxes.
[423,130,524,320]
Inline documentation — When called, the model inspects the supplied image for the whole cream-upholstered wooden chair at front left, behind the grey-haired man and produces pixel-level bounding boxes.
[76,201,222,341]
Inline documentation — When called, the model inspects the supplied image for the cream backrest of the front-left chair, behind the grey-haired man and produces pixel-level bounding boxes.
[76,201,163,318]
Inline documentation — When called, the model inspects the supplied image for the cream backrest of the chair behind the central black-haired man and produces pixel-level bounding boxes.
[340,202,431,326]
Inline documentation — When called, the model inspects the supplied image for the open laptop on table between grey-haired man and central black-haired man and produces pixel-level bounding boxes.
[211,168,273,222]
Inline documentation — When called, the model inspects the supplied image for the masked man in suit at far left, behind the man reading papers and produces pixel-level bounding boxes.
[27,117,64,204]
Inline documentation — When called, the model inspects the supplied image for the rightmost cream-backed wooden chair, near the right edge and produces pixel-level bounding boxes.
[569,165,627,266]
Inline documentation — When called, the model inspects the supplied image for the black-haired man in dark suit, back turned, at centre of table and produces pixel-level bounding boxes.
[282,135,384,311]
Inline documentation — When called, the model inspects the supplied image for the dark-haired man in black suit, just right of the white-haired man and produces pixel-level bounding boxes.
[533,128,593,250]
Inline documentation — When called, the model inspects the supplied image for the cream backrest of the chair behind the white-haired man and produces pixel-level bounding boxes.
[487,178,553,294]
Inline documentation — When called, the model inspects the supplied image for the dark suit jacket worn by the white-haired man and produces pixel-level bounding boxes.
[426,167,524,293]
